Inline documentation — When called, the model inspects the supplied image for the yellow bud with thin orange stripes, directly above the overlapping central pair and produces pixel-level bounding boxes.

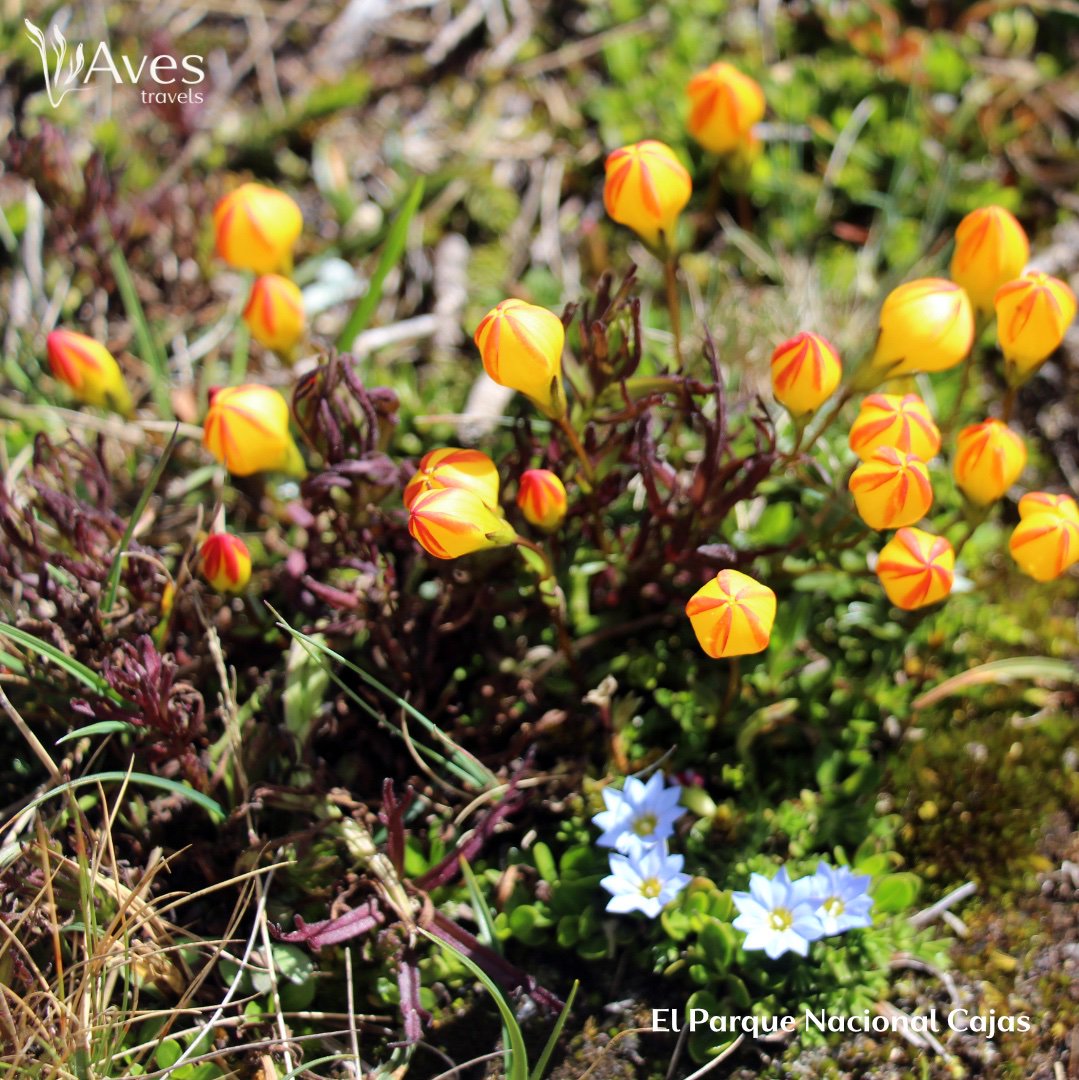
[473,300,566,420]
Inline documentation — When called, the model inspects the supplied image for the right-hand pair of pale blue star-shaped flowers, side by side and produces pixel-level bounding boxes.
[731,862,873,960]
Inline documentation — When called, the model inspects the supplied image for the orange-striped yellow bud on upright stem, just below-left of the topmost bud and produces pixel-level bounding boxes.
[603,138,693,247]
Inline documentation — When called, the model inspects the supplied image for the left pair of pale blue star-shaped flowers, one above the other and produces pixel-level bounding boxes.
[592,772,690,919]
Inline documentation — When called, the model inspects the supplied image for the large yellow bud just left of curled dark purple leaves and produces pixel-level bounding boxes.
[202,382,302,476]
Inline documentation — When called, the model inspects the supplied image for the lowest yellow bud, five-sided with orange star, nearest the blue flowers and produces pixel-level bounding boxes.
[686,570,775,660]
